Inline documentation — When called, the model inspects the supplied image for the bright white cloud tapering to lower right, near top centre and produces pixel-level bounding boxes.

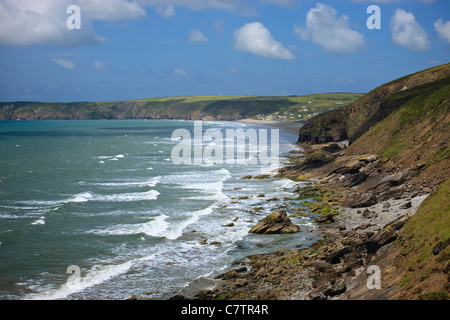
[233,22,295,60]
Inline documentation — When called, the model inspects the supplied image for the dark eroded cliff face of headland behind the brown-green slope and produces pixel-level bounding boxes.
[298,64,450,144]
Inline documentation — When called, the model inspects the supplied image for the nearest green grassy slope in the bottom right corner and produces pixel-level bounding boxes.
[392,179,450,300]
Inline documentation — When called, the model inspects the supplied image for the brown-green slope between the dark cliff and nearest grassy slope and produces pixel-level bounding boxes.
[347,77,450,189]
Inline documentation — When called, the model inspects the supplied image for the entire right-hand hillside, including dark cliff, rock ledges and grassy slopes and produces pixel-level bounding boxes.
[293,64,450,299]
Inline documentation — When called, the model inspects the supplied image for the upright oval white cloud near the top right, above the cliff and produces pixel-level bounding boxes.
[390,9,431,51]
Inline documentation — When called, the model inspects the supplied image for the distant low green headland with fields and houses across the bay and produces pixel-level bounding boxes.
[0,93,361,121]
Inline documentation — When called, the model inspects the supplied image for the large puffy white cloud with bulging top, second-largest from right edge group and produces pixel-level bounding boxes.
[294,3,365,53]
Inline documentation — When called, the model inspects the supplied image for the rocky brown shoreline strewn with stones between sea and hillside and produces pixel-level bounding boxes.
[171,139,430,300]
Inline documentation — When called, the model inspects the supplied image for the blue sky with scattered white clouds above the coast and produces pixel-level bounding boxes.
[0,0,450,102]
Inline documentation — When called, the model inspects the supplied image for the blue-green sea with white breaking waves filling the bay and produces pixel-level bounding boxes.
[0,120,317,300]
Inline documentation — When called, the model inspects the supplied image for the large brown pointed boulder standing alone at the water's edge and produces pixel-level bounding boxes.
[249,210,300,234]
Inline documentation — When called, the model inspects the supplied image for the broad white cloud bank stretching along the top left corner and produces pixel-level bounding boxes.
[0,0,252,46]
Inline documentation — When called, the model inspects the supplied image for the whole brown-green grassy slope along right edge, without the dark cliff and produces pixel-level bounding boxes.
[338,67,450,300]
